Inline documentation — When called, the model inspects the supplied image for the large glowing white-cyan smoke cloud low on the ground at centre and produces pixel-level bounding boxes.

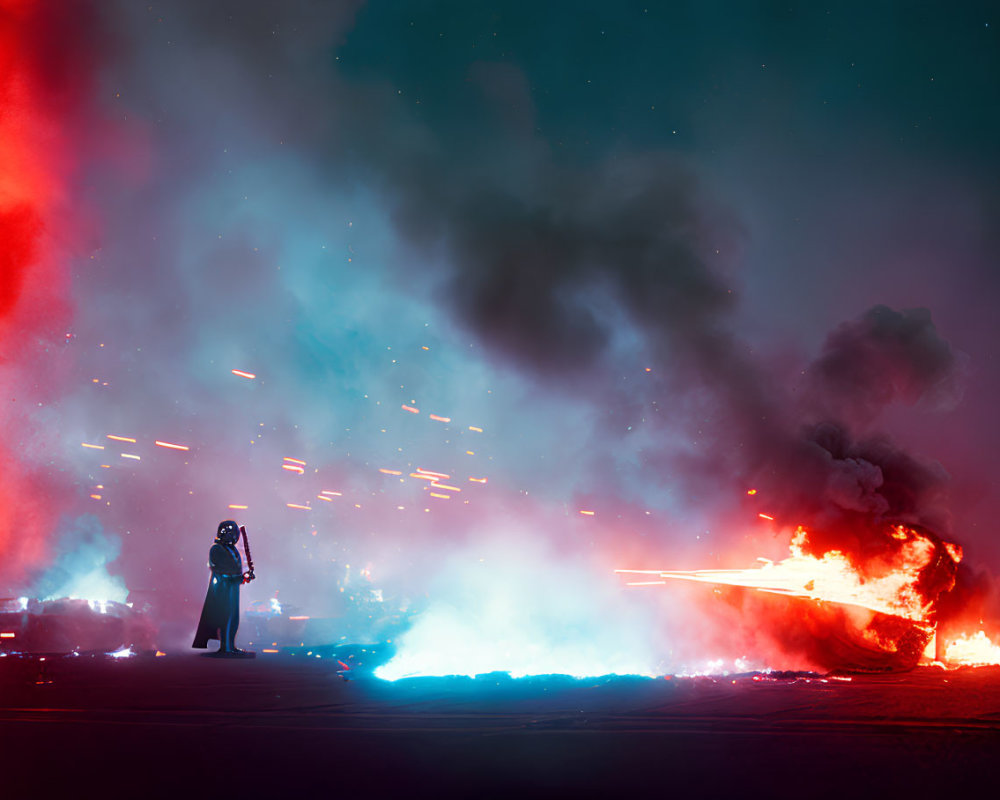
[377,530,663,680]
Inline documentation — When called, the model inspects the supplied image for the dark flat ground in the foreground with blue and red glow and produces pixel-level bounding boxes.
[0,654,1000,799]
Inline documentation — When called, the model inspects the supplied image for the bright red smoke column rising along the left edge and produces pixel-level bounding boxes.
[0,0,93,588]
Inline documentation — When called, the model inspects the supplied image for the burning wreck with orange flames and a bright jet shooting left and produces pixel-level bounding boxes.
[616,522,962,672]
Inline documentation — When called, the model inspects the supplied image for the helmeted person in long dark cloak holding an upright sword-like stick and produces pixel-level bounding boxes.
[191,519,254,658]
